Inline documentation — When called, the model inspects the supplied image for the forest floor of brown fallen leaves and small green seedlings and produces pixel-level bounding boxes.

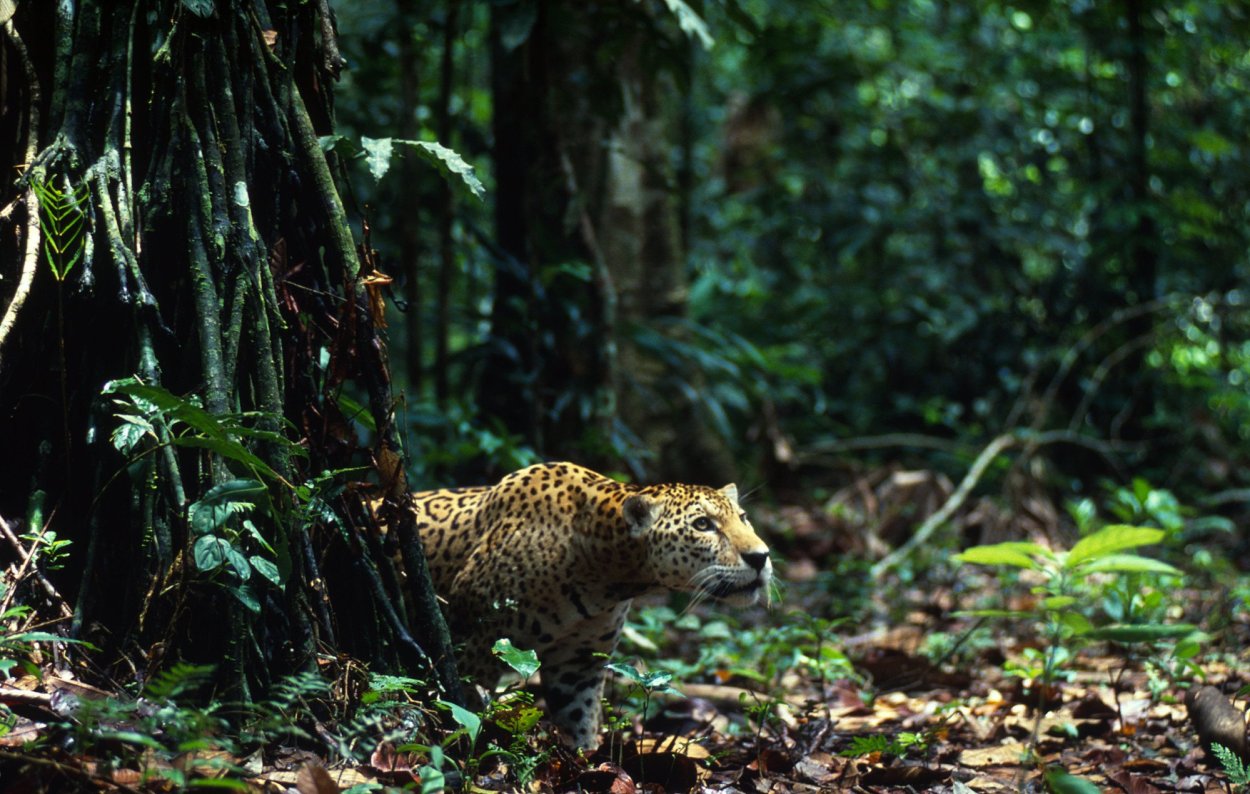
[0,477,1250,794]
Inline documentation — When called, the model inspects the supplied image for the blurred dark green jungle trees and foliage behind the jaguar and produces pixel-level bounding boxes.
[338,3,1248,498]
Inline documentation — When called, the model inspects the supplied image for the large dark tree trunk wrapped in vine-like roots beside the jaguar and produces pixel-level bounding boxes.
[0,0,455,695]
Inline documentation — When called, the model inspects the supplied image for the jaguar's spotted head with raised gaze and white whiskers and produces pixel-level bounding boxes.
[621,485,773,606]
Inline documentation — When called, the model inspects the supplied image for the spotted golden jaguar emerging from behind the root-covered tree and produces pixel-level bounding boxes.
[413,463,773,748]
